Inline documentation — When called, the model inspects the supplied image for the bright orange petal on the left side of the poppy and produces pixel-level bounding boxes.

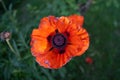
[30,29,48,56]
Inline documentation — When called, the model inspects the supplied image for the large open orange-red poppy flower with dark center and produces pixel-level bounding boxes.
[30,15,89,69]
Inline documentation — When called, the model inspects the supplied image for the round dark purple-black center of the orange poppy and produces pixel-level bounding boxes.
[52,33,67,48]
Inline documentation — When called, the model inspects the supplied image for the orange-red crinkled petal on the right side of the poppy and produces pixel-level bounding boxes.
[66,28,89,56]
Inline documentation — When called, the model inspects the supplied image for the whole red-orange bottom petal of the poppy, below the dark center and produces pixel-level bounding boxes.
[36,50,71,69]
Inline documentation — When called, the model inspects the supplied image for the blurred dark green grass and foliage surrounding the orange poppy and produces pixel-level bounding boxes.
[0,0,120,80]
